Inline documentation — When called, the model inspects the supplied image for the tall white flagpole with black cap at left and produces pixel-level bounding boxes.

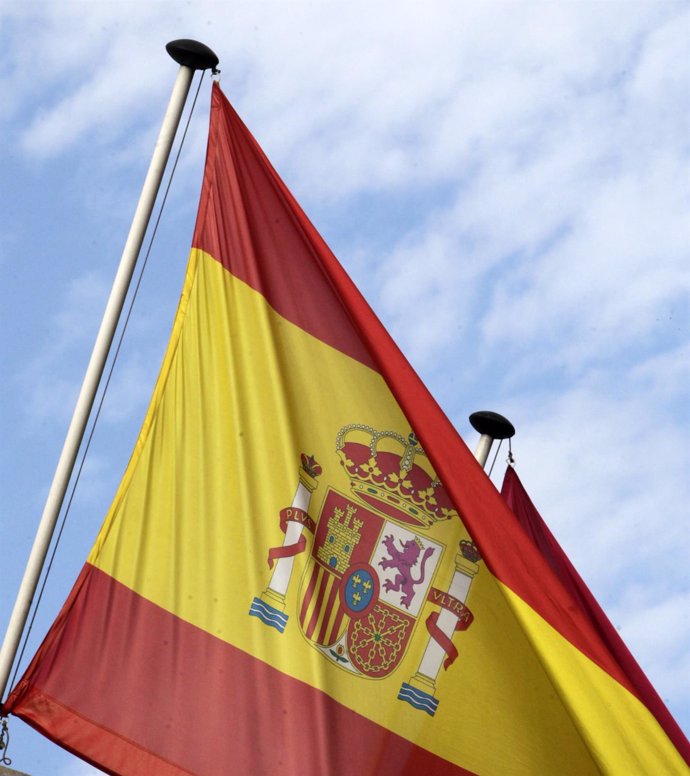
[0,40,218,698]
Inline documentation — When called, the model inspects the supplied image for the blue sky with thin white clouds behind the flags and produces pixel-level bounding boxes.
[0,0,690,776]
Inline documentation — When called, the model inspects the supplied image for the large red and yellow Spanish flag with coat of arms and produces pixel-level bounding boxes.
[4,85,690,776]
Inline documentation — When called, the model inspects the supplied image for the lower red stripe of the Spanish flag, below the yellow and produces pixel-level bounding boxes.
[4,564,471,776]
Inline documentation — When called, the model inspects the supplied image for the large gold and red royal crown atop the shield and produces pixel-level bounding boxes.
[336,423,458,528]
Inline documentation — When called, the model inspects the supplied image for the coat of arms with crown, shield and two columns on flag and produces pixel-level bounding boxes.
[249,424,479,715]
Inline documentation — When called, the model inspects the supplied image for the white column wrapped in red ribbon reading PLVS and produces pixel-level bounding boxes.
[249,454,322,633]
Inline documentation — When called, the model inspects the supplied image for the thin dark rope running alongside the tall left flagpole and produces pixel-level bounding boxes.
[9,71,204,688]
